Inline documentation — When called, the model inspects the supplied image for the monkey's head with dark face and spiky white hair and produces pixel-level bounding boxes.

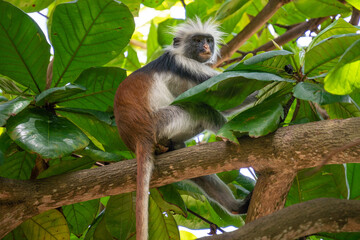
[172,19,222,63]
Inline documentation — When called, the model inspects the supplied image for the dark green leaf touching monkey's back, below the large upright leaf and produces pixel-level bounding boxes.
[59,67,126,111]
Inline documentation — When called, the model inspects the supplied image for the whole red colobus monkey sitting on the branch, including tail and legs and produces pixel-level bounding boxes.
[114,20,248,240]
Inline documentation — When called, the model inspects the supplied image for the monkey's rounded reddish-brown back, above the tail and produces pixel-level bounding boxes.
[114,71,155,151]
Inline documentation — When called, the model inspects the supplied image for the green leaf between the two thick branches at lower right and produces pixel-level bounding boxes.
[286,165,348,206]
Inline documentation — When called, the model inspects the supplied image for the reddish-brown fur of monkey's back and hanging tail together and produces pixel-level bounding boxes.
[114,71,156,240]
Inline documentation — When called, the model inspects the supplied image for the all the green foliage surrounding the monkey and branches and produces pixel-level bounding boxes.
[0,0,360,240]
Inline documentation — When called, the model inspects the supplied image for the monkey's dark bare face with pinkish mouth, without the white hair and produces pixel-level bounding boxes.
[184,34,214,62]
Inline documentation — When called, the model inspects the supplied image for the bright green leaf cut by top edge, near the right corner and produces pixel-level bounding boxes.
[294,0,351,18]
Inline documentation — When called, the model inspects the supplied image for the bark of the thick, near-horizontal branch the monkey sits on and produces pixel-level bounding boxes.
[0,118,360,238]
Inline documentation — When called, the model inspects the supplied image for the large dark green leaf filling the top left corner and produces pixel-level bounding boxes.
[0,1,50,93]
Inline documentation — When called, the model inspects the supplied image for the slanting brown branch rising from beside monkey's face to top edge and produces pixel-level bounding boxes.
[214,0,291,67]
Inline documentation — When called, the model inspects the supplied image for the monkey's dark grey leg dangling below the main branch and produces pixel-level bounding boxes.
[190,174,251,214]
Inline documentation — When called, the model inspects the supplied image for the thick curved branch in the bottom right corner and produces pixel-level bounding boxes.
[200,198,360,240]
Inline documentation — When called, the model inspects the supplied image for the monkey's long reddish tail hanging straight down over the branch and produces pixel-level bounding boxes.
[136,142,154,240]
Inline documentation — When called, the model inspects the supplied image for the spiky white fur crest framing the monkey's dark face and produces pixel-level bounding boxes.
[168,17,223,63]
